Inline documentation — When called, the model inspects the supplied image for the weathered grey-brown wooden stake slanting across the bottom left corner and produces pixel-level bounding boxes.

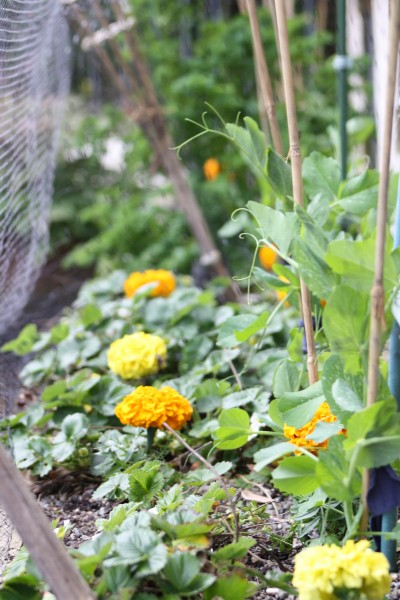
[0,444,94,600]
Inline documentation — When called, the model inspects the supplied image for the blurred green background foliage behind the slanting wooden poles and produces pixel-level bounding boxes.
[52,0,368,274]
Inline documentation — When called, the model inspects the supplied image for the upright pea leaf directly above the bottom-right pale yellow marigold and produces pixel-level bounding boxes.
[316,436,361,502]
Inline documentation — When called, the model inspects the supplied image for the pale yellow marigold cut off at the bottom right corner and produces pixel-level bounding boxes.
[293,540,390,600]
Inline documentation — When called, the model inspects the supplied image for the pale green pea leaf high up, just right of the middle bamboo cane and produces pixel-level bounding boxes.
[303,152,341,202]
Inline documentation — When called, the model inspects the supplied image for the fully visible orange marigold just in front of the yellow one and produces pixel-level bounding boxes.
[115,385,193,429]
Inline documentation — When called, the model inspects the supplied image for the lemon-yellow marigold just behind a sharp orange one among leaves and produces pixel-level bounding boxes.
[107,331,167,379]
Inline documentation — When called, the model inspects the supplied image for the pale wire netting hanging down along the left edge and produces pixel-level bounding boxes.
[0,0,70,575]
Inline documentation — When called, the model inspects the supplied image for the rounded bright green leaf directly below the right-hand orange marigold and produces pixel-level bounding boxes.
[272,456,319,496]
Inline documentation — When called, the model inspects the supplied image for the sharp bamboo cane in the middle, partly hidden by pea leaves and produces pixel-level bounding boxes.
[275,0,318,384]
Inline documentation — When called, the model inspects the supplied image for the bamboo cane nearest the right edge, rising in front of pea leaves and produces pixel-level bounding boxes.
[361,0,400,531]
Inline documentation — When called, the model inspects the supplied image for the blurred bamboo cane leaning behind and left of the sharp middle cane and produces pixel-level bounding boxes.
[246,0,283,156]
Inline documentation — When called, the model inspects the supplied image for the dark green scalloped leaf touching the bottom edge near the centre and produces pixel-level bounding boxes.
[159,552,215,597]
